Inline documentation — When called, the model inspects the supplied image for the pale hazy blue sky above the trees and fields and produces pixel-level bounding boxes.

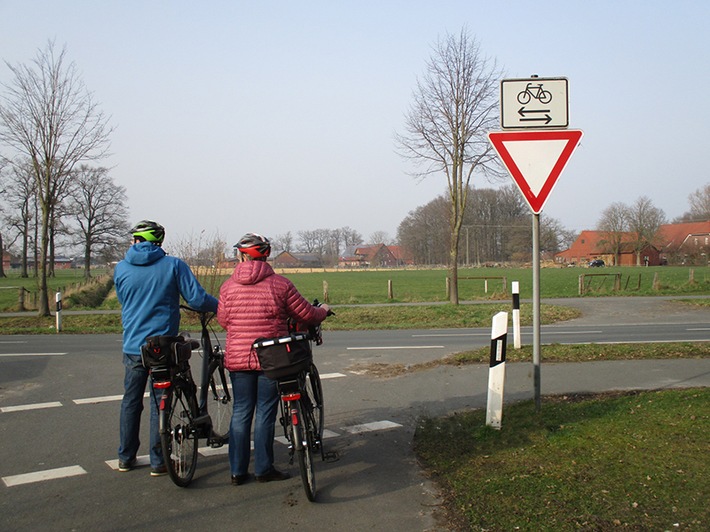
[0,0,710,250]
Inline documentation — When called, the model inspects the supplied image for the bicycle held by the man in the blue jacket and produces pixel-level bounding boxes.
[142,305,232,487]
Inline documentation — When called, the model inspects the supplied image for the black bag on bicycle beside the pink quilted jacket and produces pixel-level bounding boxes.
[253,333,313,379]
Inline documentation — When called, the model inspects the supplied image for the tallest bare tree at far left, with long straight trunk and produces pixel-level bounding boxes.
[0,41,111,316]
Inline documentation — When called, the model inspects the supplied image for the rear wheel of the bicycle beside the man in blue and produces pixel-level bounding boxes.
[160,382,197,487]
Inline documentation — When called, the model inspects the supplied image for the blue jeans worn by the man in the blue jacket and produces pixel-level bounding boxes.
[118,353,164,467]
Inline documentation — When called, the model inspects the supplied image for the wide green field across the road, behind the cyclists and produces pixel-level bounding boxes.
[0,266,710,311]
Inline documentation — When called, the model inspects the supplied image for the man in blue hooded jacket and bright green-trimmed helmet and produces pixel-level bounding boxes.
[113,220,217,476]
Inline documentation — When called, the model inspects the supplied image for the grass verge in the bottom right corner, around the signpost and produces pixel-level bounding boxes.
[415,389,710,531]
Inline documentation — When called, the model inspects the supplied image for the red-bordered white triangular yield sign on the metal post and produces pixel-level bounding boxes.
[488,129,582,214]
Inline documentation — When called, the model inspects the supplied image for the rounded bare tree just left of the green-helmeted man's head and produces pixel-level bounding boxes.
[69,164,129,279]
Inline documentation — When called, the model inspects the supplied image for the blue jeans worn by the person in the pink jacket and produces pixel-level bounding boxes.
[229,371,279,476]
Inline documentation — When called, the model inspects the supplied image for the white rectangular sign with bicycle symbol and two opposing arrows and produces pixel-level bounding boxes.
[500,78,569,129]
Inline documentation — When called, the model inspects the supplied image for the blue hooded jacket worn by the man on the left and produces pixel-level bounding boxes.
[113,242,217,355]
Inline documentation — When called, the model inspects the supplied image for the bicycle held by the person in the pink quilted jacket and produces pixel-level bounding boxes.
[253,300,335,502]
